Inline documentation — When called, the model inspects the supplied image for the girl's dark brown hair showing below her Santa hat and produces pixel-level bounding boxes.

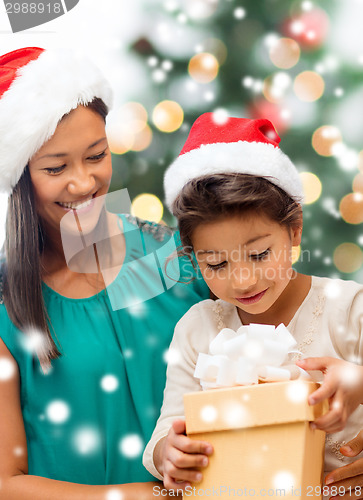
[172,173,302,258]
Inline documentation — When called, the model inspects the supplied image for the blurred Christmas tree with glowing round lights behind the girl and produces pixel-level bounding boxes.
[108,0,363,281]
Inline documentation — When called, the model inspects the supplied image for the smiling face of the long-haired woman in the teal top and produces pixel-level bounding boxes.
[29,106,112,240]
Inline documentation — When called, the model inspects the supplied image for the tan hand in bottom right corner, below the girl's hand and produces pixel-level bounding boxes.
[325,431,363,500]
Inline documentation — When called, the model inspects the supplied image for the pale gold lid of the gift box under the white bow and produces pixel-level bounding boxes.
[184,380,328,434]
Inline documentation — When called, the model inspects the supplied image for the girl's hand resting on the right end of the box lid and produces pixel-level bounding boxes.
[296,357,363,432]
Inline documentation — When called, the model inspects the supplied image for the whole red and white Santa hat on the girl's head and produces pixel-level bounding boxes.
[164,113,303,209]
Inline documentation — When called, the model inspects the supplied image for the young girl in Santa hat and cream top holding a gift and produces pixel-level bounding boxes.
[144,113,363,496]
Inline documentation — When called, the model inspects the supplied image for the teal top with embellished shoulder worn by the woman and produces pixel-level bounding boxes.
[0,216,208,485]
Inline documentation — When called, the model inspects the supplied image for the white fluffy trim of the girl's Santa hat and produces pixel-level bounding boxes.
[164,141,304,210]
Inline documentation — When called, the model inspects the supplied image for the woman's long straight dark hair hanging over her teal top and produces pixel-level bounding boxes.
[1,97,108,369]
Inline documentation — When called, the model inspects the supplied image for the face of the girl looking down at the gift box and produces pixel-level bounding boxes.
[192,214,301,314]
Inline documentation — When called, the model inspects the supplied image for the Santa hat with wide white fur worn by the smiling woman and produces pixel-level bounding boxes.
[0,47,112,193]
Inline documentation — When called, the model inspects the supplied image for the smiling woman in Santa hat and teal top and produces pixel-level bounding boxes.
[0,48,208,500]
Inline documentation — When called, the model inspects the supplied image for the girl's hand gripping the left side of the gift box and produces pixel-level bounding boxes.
[162,420,213,490]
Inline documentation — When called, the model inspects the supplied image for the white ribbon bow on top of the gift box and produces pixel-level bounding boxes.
[194,323,311,390]
